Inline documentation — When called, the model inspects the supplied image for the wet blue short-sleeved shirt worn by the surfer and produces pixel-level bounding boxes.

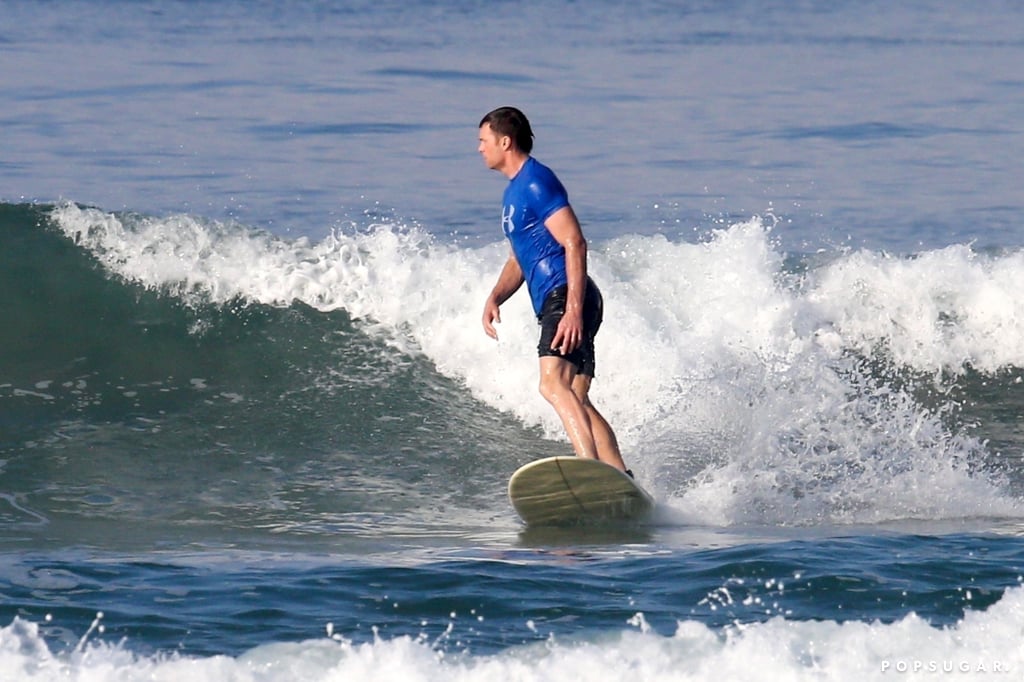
[502,157,569,315]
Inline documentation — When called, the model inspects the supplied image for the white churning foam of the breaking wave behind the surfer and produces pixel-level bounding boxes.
[53,204,1024,524]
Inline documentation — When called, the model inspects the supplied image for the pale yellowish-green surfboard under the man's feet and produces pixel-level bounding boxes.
[509,457,654,525]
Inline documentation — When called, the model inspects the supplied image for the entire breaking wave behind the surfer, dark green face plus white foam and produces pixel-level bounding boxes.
[0,199,1024,532]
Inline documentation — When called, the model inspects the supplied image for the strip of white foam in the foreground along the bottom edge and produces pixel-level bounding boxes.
[0,587,1024,682]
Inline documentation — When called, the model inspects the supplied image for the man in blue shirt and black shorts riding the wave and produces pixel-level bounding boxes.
[478,106,633,476]
